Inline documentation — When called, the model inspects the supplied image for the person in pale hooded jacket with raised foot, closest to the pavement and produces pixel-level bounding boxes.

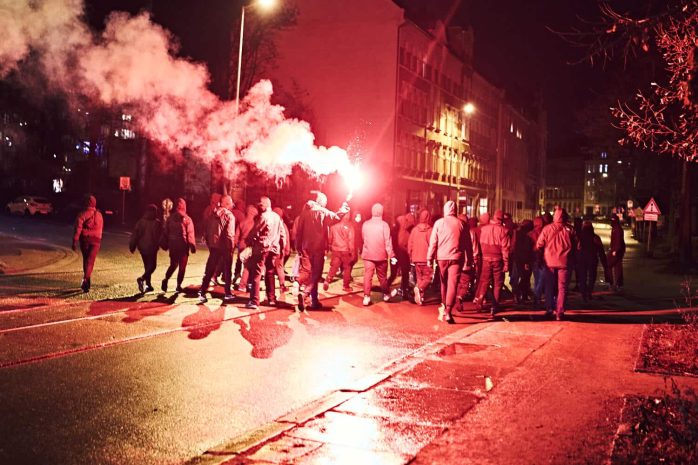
[427,200,474,324]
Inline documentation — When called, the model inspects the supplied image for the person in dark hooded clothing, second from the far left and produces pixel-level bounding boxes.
[128,203,162,294]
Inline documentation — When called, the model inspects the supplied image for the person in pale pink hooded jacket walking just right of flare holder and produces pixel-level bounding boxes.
[361,203,397,306]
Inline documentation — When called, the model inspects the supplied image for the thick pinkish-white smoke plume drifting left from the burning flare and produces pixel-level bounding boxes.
[0,0,351,178]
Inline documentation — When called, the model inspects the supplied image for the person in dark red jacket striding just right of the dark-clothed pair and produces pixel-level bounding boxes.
[199,195,235,303]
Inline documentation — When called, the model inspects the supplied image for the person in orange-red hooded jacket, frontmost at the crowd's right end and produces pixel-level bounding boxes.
[536,208,577,321]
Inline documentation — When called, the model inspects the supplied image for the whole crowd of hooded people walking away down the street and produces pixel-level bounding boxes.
[73,192,625,323]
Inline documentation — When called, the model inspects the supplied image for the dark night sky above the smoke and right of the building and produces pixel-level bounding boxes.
[87,0,604,156]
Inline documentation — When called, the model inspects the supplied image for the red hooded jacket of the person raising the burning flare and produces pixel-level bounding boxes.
[296,200,348,253]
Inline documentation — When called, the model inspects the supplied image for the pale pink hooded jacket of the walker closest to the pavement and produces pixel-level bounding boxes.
[427,200,474,266]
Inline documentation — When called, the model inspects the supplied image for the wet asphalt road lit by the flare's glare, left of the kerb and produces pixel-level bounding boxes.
[0,216,470,465]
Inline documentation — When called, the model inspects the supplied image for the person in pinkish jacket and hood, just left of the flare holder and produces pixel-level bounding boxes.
[245,197,288,310]
